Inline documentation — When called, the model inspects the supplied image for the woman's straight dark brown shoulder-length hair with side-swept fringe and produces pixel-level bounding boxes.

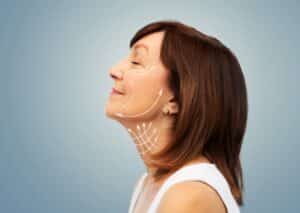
[130,20,248,205]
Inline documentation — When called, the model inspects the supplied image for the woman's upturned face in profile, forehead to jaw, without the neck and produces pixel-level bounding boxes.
[106,32,171,119]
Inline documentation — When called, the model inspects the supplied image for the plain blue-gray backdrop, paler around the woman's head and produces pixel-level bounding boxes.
[0,0,300,213]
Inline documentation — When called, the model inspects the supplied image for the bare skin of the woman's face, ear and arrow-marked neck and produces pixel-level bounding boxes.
[106,32,178,174]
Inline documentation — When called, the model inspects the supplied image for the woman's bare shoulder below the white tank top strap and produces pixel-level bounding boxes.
[157,181,226,213]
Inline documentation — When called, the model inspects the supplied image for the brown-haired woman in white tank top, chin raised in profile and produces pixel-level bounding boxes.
[106,20,248,213]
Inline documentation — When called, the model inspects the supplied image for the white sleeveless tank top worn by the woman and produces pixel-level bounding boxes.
[128,162,240,213]
